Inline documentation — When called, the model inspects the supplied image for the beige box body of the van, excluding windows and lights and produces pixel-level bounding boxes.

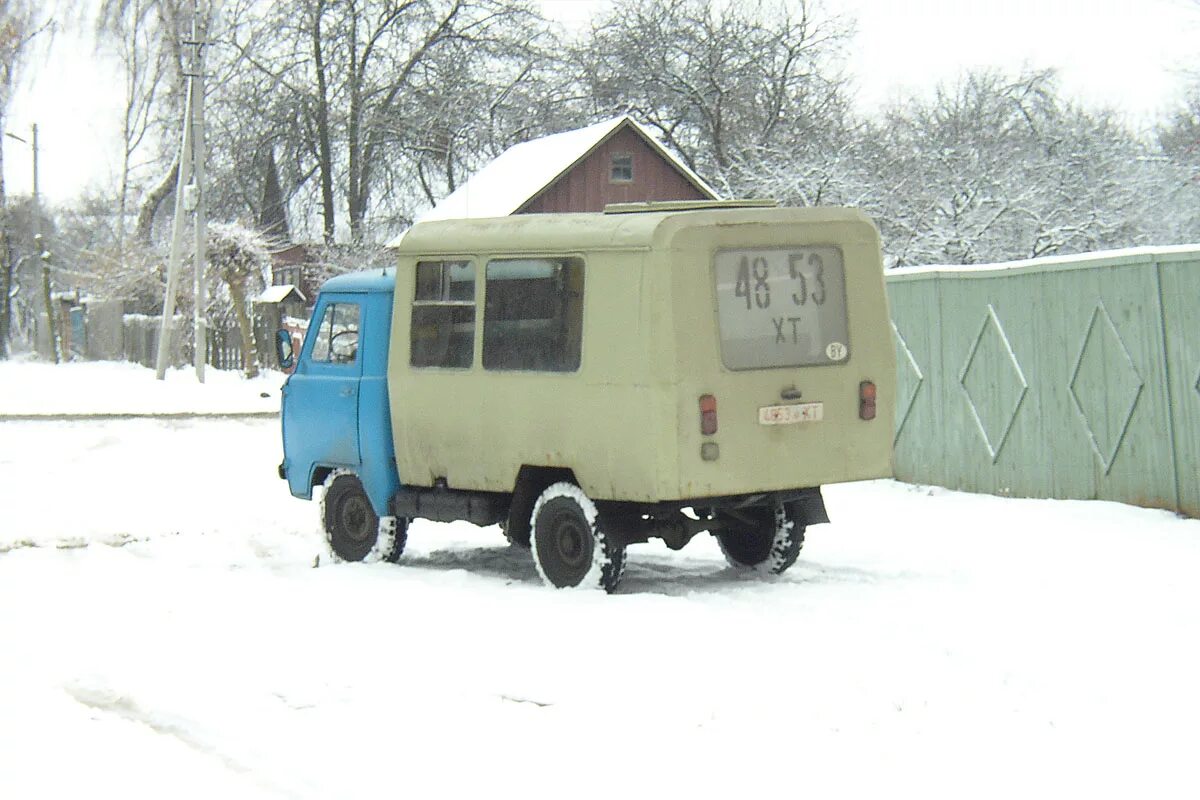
[388,207,895,501]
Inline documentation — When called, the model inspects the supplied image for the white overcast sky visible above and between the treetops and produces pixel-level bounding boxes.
[4,0,1200,203]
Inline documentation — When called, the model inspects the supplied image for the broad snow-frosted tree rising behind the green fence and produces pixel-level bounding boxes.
[863,71,1180,265]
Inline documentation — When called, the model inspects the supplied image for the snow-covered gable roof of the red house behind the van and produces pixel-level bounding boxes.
[416,114,719,222]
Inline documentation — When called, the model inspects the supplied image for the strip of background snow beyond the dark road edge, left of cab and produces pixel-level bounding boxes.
[0,357,283,417]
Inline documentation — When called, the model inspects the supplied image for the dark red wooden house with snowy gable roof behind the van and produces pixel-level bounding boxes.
[416,114,719,222]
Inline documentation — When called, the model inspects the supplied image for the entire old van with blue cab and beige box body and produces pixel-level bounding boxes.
[281,203,895,591]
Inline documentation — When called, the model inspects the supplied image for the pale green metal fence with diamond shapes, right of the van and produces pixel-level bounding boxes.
[888,246,1200,517]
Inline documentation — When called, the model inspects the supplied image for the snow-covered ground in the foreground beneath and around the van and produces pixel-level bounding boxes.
[0,420,1200,798]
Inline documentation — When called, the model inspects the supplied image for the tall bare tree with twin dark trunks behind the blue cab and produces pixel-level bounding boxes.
[233,0,545,242]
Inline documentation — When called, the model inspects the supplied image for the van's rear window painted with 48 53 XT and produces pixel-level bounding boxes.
[714,246,850,369]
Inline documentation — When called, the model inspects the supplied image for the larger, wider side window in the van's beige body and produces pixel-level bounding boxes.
[484,258,583,372]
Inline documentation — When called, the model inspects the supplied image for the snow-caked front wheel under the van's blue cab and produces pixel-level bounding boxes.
[320,470,408,563]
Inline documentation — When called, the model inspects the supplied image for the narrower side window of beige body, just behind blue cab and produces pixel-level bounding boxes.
[409,261,475,369]
